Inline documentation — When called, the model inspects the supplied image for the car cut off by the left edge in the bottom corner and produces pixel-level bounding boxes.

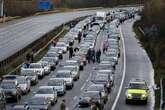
[0,88,6,110]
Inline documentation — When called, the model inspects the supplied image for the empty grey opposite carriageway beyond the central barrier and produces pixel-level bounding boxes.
[0,10,109,61]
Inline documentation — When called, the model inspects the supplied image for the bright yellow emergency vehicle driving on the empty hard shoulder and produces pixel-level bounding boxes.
[125,79,149,104]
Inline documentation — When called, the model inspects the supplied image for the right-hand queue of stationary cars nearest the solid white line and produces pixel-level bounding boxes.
[78,17,120,110]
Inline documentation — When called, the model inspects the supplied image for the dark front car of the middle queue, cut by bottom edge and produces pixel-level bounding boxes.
[26,97,51,110]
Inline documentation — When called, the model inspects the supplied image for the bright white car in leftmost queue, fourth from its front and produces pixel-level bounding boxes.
[27,63,45,78]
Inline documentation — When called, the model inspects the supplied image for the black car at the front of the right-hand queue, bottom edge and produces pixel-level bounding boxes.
[78,91,104,110]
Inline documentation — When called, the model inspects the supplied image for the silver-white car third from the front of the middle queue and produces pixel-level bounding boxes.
[48,78,66,95]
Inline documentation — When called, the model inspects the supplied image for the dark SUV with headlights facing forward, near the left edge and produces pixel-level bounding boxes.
[0,80,21,102]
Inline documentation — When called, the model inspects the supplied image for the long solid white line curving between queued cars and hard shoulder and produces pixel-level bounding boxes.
[111,26,126,110]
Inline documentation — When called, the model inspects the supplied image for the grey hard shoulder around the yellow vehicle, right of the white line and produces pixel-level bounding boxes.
[115,17,154,110]
